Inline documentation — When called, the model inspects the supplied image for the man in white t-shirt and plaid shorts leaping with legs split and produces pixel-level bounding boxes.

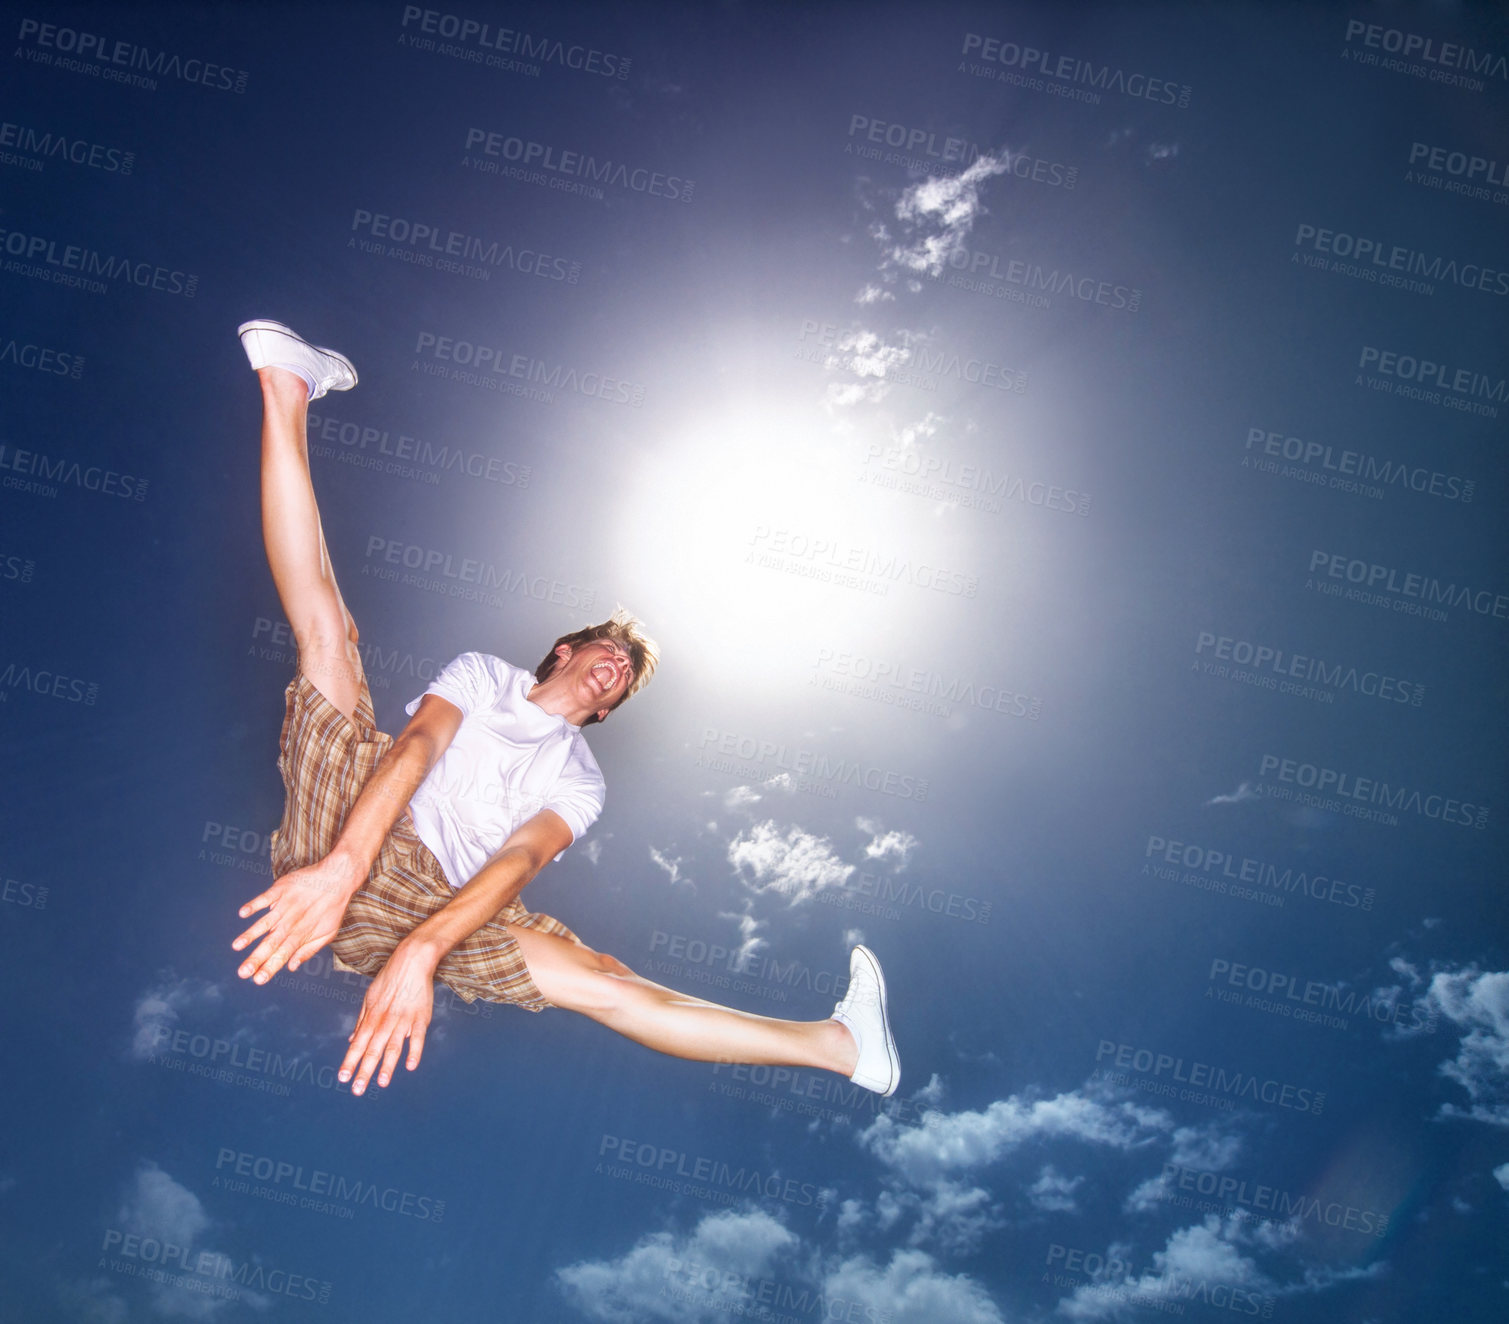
[231,322,901,1095]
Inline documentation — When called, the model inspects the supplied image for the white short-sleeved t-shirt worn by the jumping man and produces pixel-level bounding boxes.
[404,652,604,888]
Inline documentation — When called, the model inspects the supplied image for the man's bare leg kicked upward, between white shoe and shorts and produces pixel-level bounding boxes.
[257,367,364,717]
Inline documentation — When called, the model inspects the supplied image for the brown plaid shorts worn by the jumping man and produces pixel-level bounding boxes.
[272,672,581,1011]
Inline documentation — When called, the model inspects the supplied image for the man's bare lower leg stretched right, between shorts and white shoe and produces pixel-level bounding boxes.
[509,924,859,1076]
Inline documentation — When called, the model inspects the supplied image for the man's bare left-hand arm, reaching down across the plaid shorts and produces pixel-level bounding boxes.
[231,694,462,984]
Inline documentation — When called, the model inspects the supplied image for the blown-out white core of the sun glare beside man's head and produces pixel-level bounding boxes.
[623,383,947,684]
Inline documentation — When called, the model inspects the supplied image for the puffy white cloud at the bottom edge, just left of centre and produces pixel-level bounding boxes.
[555,1209,800,1324]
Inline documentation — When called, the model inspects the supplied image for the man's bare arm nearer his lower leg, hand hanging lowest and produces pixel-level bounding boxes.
[341,809,572,1095]
